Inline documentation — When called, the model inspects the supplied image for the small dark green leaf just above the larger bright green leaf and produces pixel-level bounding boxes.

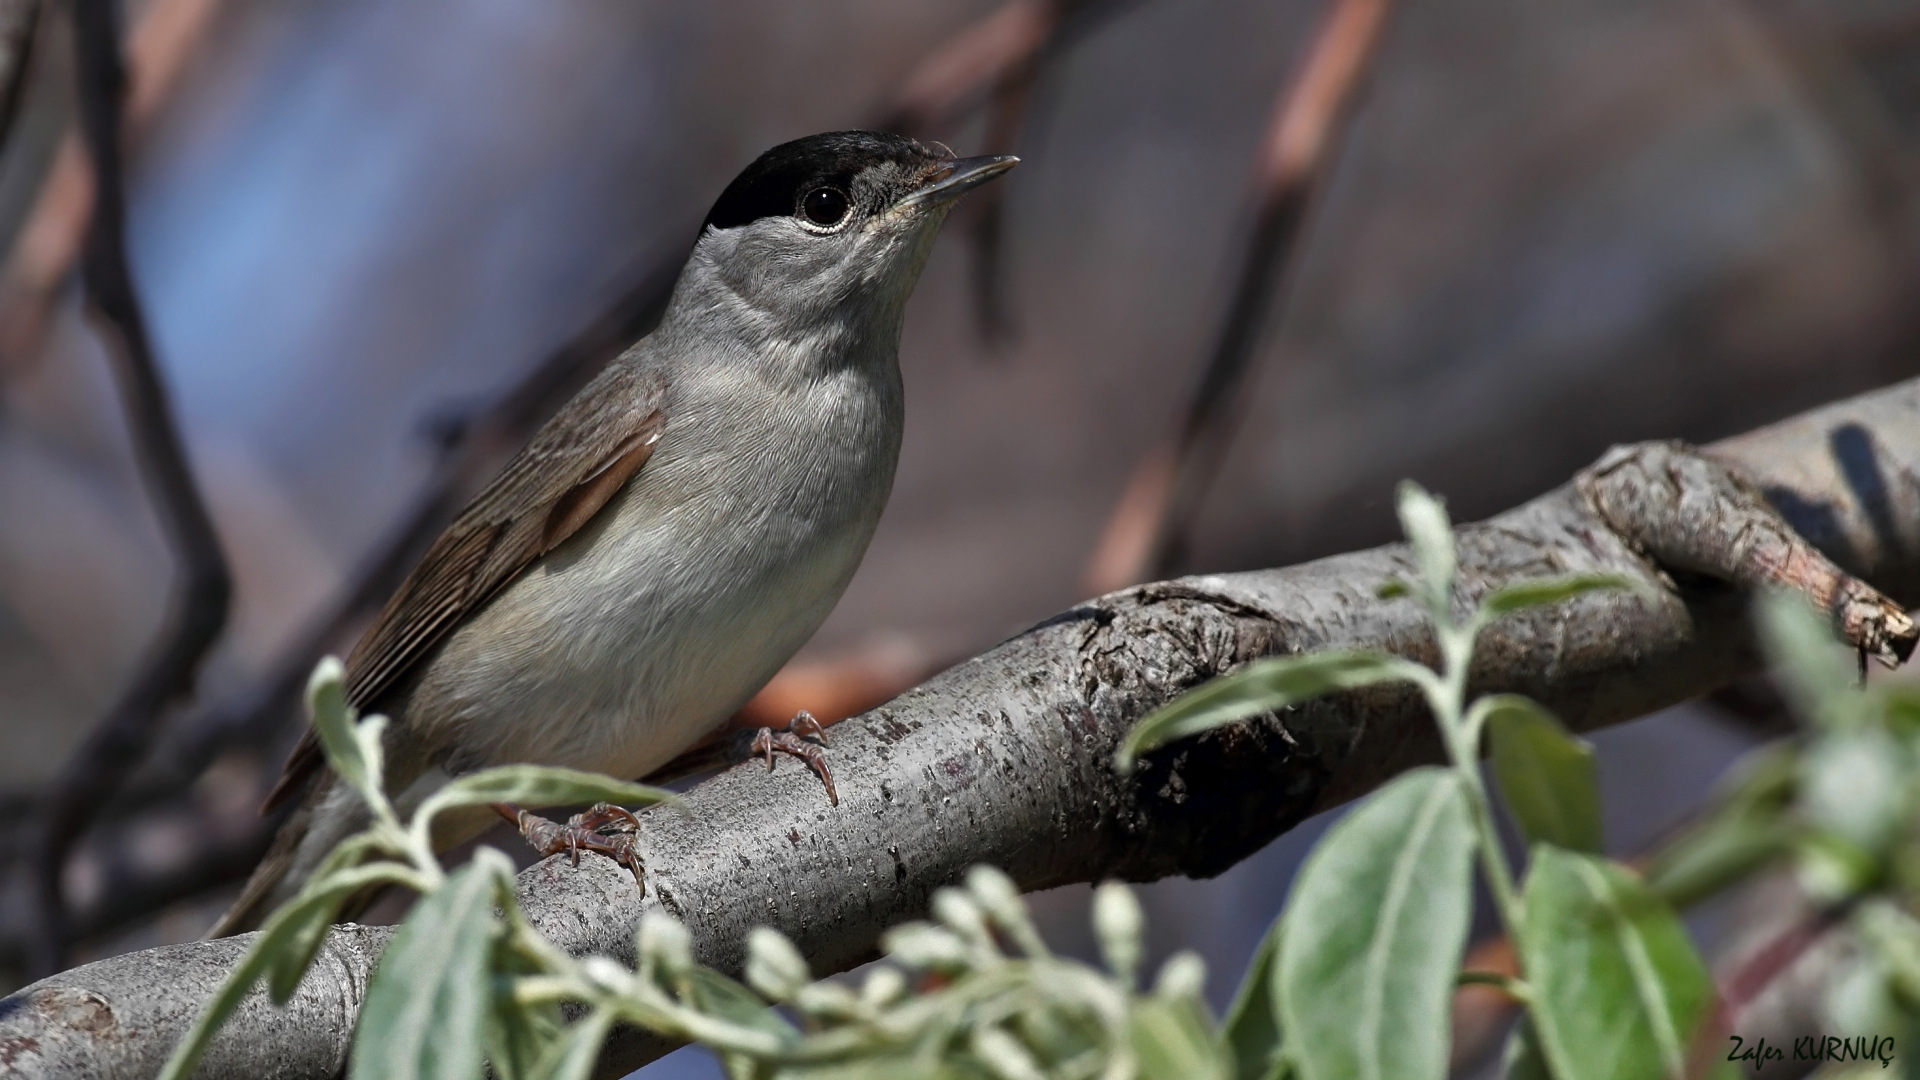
[1473,694,1599,851]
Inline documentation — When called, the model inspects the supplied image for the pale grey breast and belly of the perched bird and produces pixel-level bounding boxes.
[407,354,902,776]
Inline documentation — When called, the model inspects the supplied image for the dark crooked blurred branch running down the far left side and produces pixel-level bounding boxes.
[25,0,232,972]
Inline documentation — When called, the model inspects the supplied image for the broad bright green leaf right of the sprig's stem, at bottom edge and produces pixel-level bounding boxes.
[1521,844,1713,1080]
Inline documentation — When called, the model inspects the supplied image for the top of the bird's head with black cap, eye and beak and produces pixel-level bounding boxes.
[703,131,1018,231]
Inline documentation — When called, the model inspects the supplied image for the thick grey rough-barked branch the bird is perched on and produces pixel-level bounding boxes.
[0,382,1920,1078]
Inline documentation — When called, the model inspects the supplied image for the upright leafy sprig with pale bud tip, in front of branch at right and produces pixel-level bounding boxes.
[1117,484,1713,1080]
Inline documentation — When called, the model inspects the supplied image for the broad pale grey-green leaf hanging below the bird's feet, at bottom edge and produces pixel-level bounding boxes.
[349,849,513,1080]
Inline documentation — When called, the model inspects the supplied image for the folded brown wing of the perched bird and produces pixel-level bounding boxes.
[263,363,664,813]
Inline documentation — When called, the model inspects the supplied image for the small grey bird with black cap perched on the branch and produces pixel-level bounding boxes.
[209,131,1018,936]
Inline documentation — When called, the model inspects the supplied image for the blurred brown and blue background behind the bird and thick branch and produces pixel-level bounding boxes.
[0,0,1920,1076]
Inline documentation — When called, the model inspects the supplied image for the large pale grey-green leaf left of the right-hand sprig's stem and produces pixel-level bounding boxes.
[1277,769,1475,1080]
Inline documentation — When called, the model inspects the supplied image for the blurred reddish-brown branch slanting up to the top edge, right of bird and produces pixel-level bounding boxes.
[1085,0,1392,594]
